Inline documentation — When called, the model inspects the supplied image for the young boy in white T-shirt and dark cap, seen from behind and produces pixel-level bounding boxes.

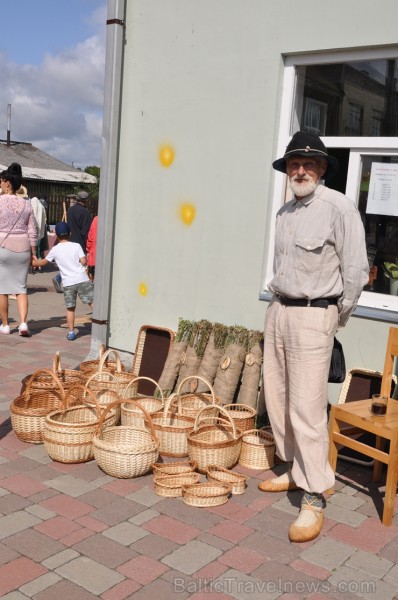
[32,222,94,341]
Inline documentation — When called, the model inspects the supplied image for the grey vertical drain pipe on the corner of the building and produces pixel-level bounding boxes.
[87,0,126,358]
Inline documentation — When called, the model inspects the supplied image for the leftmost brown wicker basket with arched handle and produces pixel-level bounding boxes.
[10,369,65,444]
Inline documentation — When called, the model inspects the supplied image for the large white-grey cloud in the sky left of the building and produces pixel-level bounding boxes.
[0,6,106,168]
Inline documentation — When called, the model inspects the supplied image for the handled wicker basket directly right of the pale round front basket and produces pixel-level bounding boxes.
[152,396,195,458]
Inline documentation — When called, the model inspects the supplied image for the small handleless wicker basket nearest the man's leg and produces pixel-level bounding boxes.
[239,428,275,471]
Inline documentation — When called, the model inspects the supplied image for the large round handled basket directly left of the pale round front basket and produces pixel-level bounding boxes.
[43,384,115,463]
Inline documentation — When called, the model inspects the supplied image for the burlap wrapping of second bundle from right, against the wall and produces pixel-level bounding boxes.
[213,344,247,404]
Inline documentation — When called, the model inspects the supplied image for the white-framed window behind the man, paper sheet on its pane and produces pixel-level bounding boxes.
[264,48,398,321]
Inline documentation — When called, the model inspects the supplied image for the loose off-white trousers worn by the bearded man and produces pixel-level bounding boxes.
[264,299,338,493]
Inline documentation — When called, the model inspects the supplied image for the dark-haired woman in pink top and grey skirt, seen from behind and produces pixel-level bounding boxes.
[0,163,37,337]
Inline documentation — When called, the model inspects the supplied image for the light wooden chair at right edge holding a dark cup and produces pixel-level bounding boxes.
[329,327,398,525]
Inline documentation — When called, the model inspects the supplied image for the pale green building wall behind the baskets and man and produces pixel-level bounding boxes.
[109,0,398,397]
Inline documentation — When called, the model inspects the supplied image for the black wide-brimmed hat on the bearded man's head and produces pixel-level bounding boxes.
[272,131,339,179]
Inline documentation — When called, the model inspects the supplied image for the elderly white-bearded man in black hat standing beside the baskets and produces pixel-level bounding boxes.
[259,132,369,542]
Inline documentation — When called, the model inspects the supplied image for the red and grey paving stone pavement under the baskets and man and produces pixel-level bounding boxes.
[0,269,398,600]
